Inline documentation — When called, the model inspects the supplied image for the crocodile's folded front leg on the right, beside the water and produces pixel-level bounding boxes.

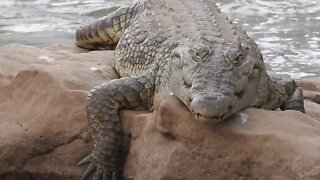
[264,76,305,113]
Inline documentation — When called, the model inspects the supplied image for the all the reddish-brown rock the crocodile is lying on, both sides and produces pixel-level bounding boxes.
[0,45,320,180]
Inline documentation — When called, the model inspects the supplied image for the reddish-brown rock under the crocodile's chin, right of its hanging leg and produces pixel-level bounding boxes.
[125,95,320,180]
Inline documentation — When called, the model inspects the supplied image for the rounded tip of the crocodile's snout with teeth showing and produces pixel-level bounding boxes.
[190,95,233,122]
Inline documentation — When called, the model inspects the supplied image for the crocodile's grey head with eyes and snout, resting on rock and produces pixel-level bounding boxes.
[169,40,266,123]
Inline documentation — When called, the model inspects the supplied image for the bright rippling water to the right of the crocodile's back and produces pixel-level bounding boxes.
[219,0,320,79]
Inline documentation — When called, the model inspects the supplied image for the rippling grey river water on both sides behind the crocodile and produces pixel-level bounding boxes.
[0,0,320,79]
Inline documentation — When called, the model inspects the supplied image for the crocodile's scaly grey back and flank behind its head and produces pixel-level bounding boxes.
[114,0,255,77]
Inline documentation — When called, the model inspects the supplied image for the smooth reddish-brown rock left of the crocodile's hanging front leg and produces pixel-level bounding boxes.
[0,45,116,179]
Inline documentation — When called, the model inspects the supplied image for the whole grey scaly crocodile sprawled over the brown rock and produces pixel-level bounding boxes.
[76,0,304,180]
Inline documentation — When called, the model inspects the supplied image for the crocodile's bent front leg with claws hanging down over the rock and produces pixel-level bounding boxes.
[79,75,154,180]
